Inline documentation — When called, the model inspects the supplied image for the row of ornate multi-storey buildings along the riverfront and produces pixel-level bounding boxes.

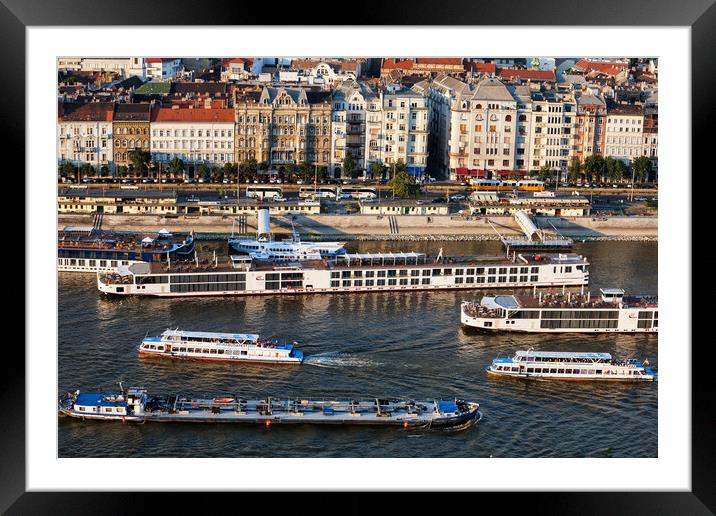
[58,58,658,178]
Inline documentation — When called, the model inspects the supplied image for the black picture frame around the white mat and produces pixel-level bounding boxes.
[5,0,716,514]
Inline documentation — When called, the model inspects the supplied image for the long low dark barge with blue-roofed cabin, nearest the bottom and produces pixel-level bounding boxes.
[58,386,482,429]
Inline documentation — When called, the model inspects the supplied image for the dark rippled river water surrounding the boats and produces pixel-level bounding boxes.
[58,242,658,457]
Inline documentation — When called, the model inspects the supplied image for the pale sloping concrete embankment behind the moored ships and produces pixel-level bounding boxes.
[58,214,658,240]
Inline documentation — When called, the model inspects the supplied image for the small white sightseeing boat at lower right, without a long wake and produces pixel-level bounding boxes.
[487,348,655,382]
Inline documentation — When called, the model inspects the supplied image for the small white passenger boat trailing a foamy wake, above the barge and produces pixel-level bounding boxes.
[139,329,303,364]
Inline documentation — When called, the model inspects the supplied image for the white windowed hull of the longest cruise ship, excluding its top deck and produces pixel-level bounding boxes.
[97,255,589,297]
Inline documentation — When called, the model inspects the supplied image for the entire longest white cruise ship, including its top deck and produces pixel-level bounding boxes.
[97,253,589,296]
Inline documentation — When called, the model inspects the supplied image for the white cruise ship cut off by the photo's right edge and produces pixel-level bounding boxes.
[460,288,659,333]
